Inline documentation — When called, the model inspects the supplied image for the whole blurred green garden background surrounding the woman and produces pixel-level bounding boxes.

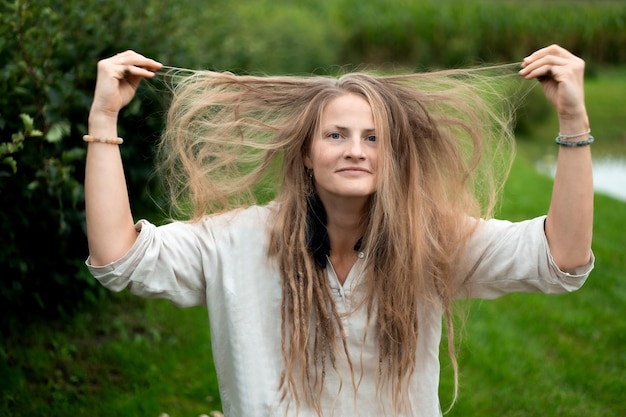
[0,0,626,417]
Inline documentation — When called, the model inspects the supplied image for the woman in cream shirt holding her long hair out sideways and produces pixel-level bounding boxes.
[85,45,593,416]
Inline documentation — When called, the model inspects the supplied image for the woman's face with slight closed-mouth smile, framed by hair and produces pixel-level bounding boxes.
[305,93,378,206]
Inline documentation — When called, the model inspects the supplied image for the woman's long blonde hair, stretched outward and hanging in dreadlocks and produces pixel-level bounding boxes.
[158,66,514,414]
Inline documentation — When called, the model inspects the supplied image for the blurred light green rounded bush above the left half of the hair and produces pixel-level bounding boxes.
[144,0,340,74]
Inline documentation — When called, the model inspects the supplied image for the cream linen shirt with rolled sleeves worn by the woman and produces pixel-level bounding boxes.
[87,203,594,417]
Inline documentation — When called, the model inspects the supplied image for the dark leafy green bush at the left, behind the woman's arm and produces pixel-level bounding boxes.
[0,0,167,319]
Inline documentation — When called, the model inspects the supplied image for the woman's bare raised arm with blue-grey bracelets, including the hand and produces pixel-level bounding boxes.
[520,45,593,271]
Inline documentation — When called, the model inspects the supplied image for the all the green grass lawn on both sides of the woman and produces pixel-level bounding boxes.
[0,71,626,417]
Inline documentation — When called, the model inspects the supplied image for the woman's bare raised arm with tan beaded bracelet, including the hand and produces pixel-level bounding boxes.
[85,51,161,265]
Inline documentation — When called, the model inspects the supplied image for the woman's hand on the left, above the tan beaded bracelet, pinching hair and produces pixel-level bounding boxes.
[90,50,163,118]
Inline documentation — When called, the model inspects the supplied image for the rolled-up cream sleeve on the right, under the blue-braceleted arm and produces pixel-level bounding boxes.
[457,216,594,299]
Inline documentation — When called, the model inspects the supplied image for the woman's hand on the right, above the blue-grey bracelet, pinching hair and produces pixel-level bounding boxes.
[519,45,587,120]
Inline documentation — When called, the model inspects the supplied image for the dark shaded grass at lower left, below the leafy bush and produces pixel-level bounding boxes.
[0,293,220,417]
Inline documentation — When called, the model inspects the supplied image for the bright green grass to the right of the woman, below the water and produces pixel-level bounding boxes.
[440,160,626,417]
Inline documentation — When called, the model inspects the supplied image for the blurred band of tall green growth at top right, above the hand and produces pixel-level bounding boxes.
[331,0,626,68]
